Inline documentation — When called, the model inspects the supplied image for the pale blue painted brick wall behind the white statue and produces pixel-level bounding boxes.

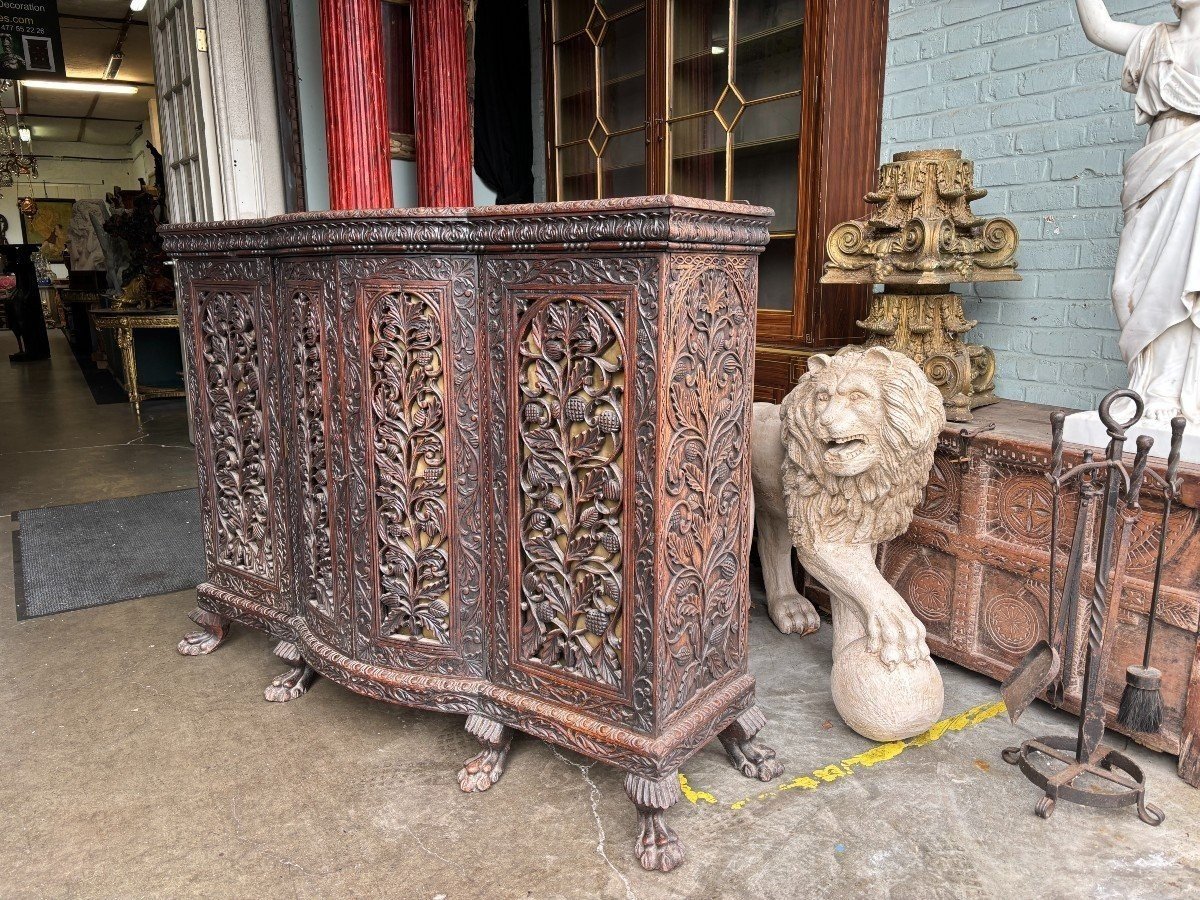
[882,0,1174,408]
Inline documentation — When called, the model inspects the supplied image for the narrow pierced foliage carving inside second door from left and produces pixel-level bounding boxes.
[292,290,334,618]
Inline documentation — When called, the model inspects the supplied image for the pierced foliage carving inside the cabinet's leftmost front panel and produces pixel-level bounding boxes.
[198,290,275,580]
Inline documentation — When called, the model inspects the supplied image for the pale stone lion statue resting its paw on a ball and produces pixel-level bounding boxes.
[752,347,946,740]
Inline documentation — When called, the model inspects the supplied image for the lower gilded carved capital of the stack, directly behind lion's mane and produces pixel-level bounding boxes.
[858,286,996,422]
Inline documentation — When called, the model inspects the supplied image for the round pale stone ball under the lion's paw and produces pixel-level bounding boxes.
[830,637,944,740]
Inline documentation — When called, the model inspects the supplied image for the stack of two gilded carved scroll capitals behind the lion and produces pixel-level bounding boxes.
[821,150,1021,421]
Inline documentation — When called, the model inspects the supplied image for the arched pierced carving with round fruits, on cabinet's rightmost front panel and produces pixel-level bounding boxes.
[516,298,625,686]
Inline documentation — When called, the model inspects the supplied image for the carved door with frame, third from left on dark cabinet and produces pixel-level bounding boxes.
[337,254,490,676]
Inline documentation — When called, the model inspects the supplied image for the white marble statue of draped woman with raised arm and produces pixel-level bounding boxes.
[1075,0,1200,427]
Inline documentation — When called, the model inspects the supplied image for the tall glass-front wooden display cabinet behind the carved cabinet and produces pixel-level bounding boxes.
[542,0,887,400]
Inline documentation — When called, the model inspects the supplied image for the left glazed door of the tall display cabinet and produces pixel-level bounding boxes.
[546,0,649,200]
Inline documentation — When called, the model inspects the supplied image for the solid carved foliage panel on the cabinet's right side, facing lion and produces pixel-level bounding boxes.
[658,256,756,715]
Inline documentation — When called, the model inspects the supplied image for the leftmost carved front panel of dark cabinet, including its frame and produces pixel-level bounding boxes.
[180,259,292,622]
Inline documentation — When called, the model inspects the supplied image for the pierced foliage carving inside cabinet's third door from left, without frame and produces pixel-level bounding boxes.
[367,290,450,644]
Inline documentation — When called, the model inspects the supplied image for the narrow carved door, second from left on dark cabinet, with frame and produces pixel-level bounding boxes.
[276,257,354,655]
